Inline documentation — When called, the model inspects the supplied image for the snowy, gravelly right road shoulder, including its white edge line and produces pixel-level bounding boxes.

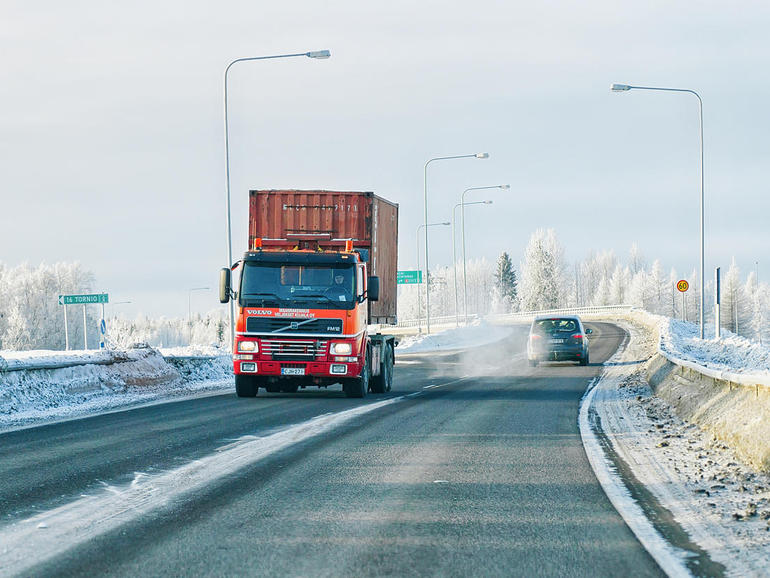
[580,323,770,576]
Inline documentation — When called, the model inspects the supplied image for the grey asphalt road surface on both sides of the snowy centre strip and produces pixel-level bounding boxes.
[0,324,662,576]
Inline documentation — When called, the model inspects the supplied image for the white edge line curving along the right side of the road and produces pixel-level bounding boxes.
[578,338,692,577]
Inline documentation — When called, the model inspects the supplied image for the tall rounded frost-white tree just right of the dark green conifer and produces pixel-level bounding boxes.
[519,229,567,311]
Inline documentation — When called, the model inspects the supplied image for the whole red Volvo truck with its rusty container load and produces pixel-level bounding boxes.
[219,190,398,397]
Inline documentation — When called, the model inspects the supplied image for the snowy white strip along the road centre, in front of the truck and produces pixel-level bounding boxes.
[0,392,404,576]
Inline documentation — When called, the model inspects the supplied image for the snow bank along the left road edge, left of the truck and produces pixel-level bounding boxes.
[0,348,232,429]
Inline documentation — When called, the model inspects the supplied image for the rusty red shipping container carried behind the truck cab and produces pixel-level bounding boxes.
[249,190,398,324]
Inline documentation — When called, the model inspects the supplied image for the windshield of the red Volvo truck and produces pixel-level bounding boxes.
[239,261,355,309]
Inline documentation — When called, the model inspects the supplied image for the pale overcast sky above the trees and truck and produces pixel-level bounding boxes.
[0,0,770,316]
